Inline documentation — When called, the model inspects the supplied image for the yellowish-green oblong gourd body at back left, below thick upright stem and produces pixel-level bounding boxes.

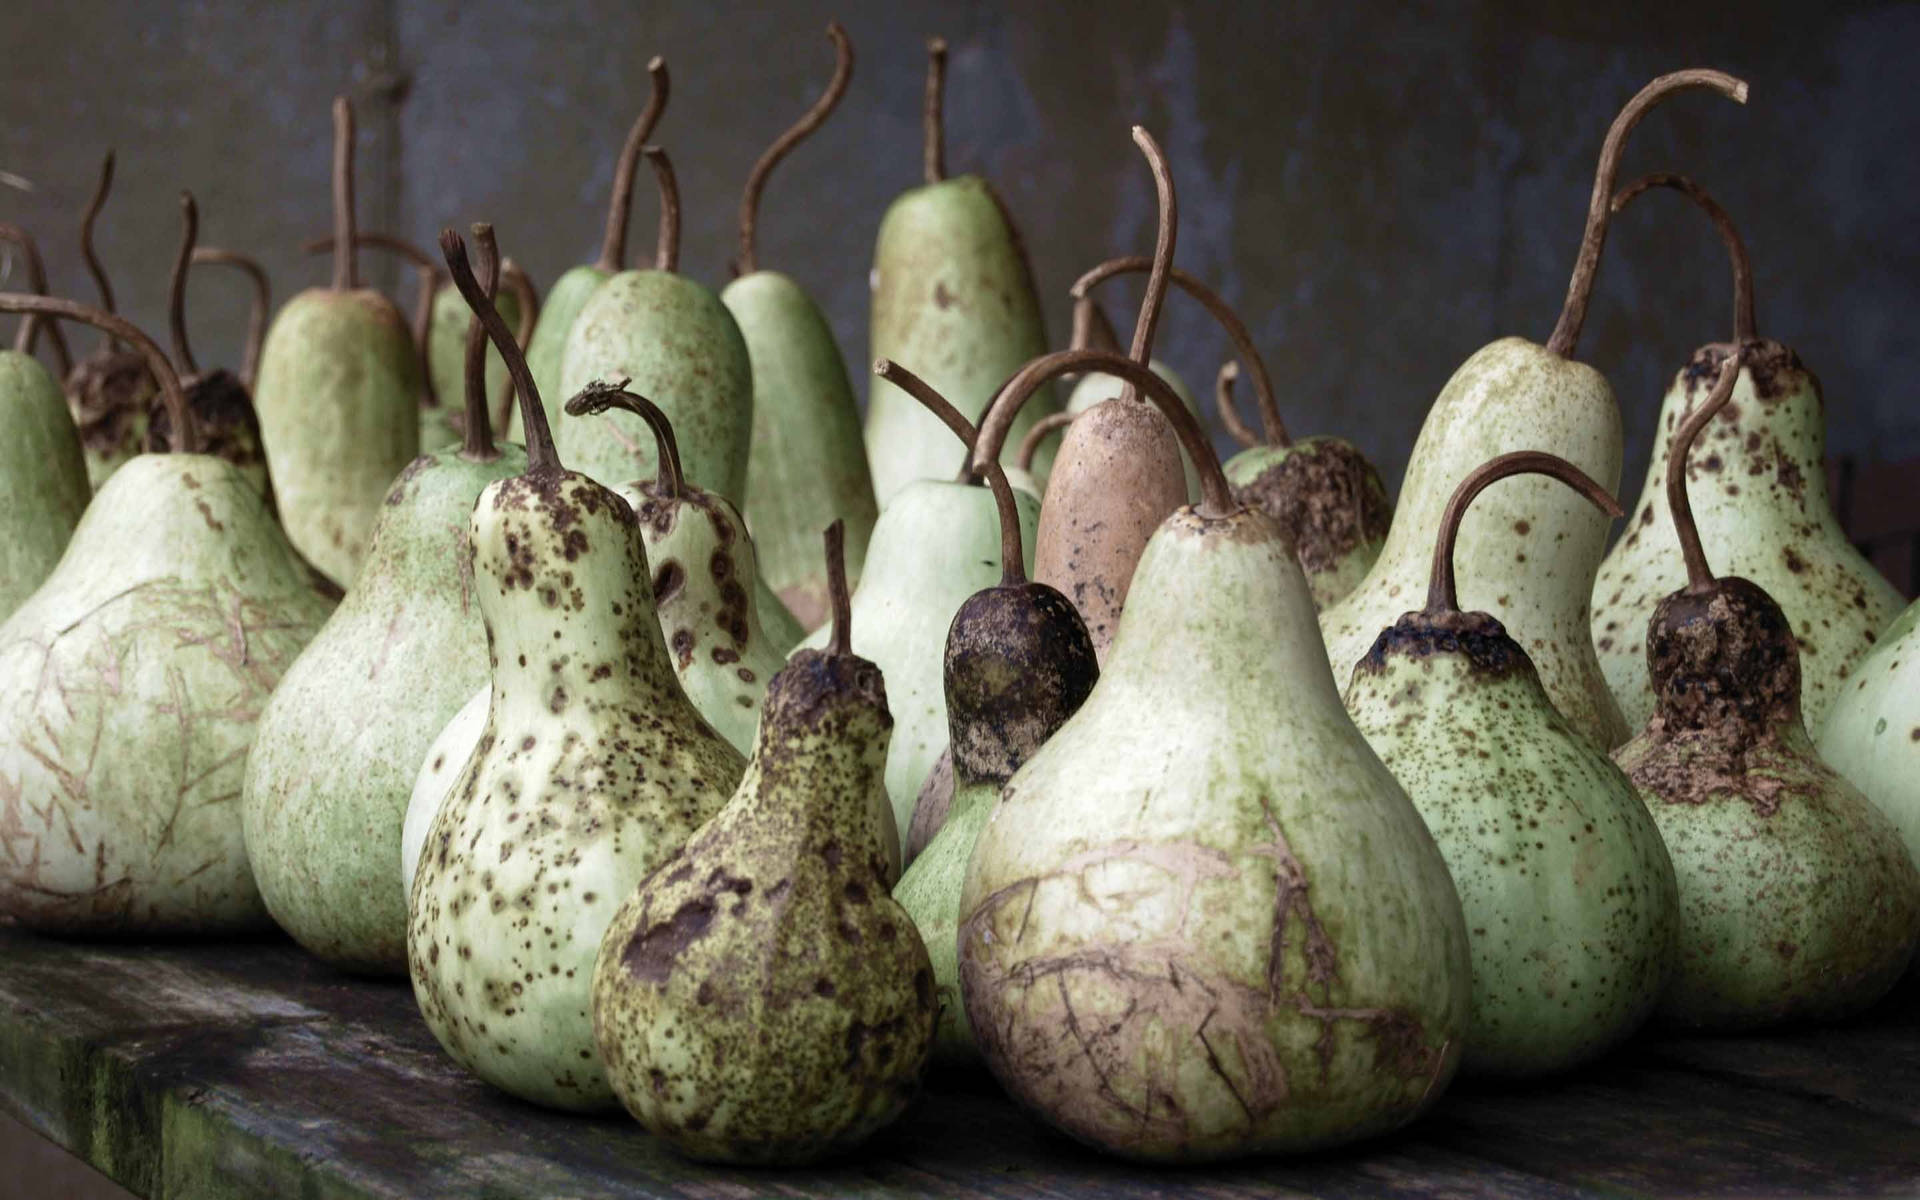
[253,288,420,588]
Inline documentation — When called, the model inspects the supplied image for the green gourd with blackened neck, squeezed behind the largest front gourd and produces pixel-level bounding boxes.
[893,437,1090,1064]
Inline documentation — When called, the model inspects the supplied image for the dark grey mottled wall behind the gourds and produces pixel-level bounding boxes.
[0,0,1920,493]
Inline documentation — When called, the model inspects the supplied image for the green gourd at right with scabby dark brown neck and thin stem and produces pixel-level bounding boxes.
[1615,342,1920,1029]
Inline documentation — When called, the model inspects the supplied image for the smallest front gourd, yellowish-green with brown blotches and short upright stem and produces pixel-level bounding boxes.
[593,524,935,1164]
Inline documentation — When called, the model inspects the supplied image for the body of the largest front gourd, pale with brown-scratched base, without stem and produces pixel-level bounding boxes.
[960,509,1471,1162]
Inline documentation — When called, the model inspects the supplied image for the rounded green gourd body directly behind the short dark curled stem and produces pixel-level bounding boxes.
[553,271,753,501]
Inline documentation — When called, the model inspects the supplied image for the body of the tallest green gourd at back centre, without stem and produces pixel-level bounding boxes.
[856,175,1060,503]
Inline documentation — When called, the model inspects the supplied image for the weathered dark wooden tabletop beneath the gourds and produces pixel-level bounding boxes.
[0,931,1920,1200]
